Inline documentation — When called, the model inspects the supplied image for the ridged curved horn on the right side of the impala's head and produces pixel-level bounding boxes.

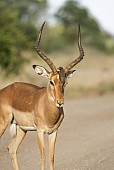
[65,25,84,73]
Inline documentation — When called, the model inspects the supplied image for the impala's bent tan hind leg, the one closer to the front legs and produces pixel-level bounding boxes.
[8,126,26,170]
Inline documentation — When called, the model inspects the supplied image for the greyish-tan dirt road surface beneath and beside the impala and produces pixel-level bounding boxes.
[0,96,114,170]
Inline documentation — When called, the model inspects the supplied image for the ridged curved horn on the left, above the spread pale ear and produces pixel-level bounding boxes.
[34,22,57,73]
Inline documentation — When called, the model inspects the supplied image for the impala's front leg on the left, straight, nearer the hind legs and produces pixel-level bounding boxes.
[38,131,45,170]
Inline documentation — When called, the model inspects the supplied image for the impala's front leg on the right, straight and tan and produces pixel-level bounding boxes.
[49,131,57,170]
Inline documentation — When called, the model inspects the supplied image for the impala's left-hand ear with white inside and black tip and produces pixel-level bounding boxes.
[33,65,50,78]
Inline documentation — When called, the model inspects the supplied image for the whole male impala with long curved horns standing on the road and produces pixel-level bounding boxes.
[0,22,84,170]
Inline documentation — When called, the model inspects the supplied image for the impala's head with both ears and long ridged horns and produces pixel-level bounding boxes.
[33,22,84,107]
